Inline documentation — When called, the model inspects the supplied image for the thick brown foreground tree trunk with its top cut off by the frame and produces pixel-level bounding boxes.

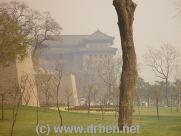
[113,0,137,129]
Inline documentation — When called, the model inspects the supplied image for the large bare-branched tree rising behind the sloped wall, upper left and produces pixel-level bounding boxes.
[0,1,62,61]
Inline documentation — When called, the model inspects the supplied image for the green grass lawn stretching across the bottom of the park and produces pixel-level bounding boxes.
[0,106,181,136]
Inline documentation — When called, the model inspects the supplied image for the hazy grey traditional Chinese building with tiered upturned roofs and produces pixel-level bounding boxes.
[40,30,117,103]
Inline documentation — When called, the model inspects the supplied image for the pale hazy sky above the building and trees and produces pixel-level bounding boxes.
[6,0,181,81]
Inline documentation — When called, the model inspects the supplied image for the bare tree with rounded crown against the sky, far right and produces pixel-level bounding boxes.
[145,44,179,106]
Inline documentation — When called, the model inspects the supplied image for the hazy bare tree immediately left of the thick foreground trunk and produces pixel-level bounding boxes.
[98,56,122,118]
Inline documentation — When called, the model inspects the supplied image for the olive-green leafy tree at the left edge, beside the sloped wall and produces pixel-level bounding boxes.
[0,12,30,66]
